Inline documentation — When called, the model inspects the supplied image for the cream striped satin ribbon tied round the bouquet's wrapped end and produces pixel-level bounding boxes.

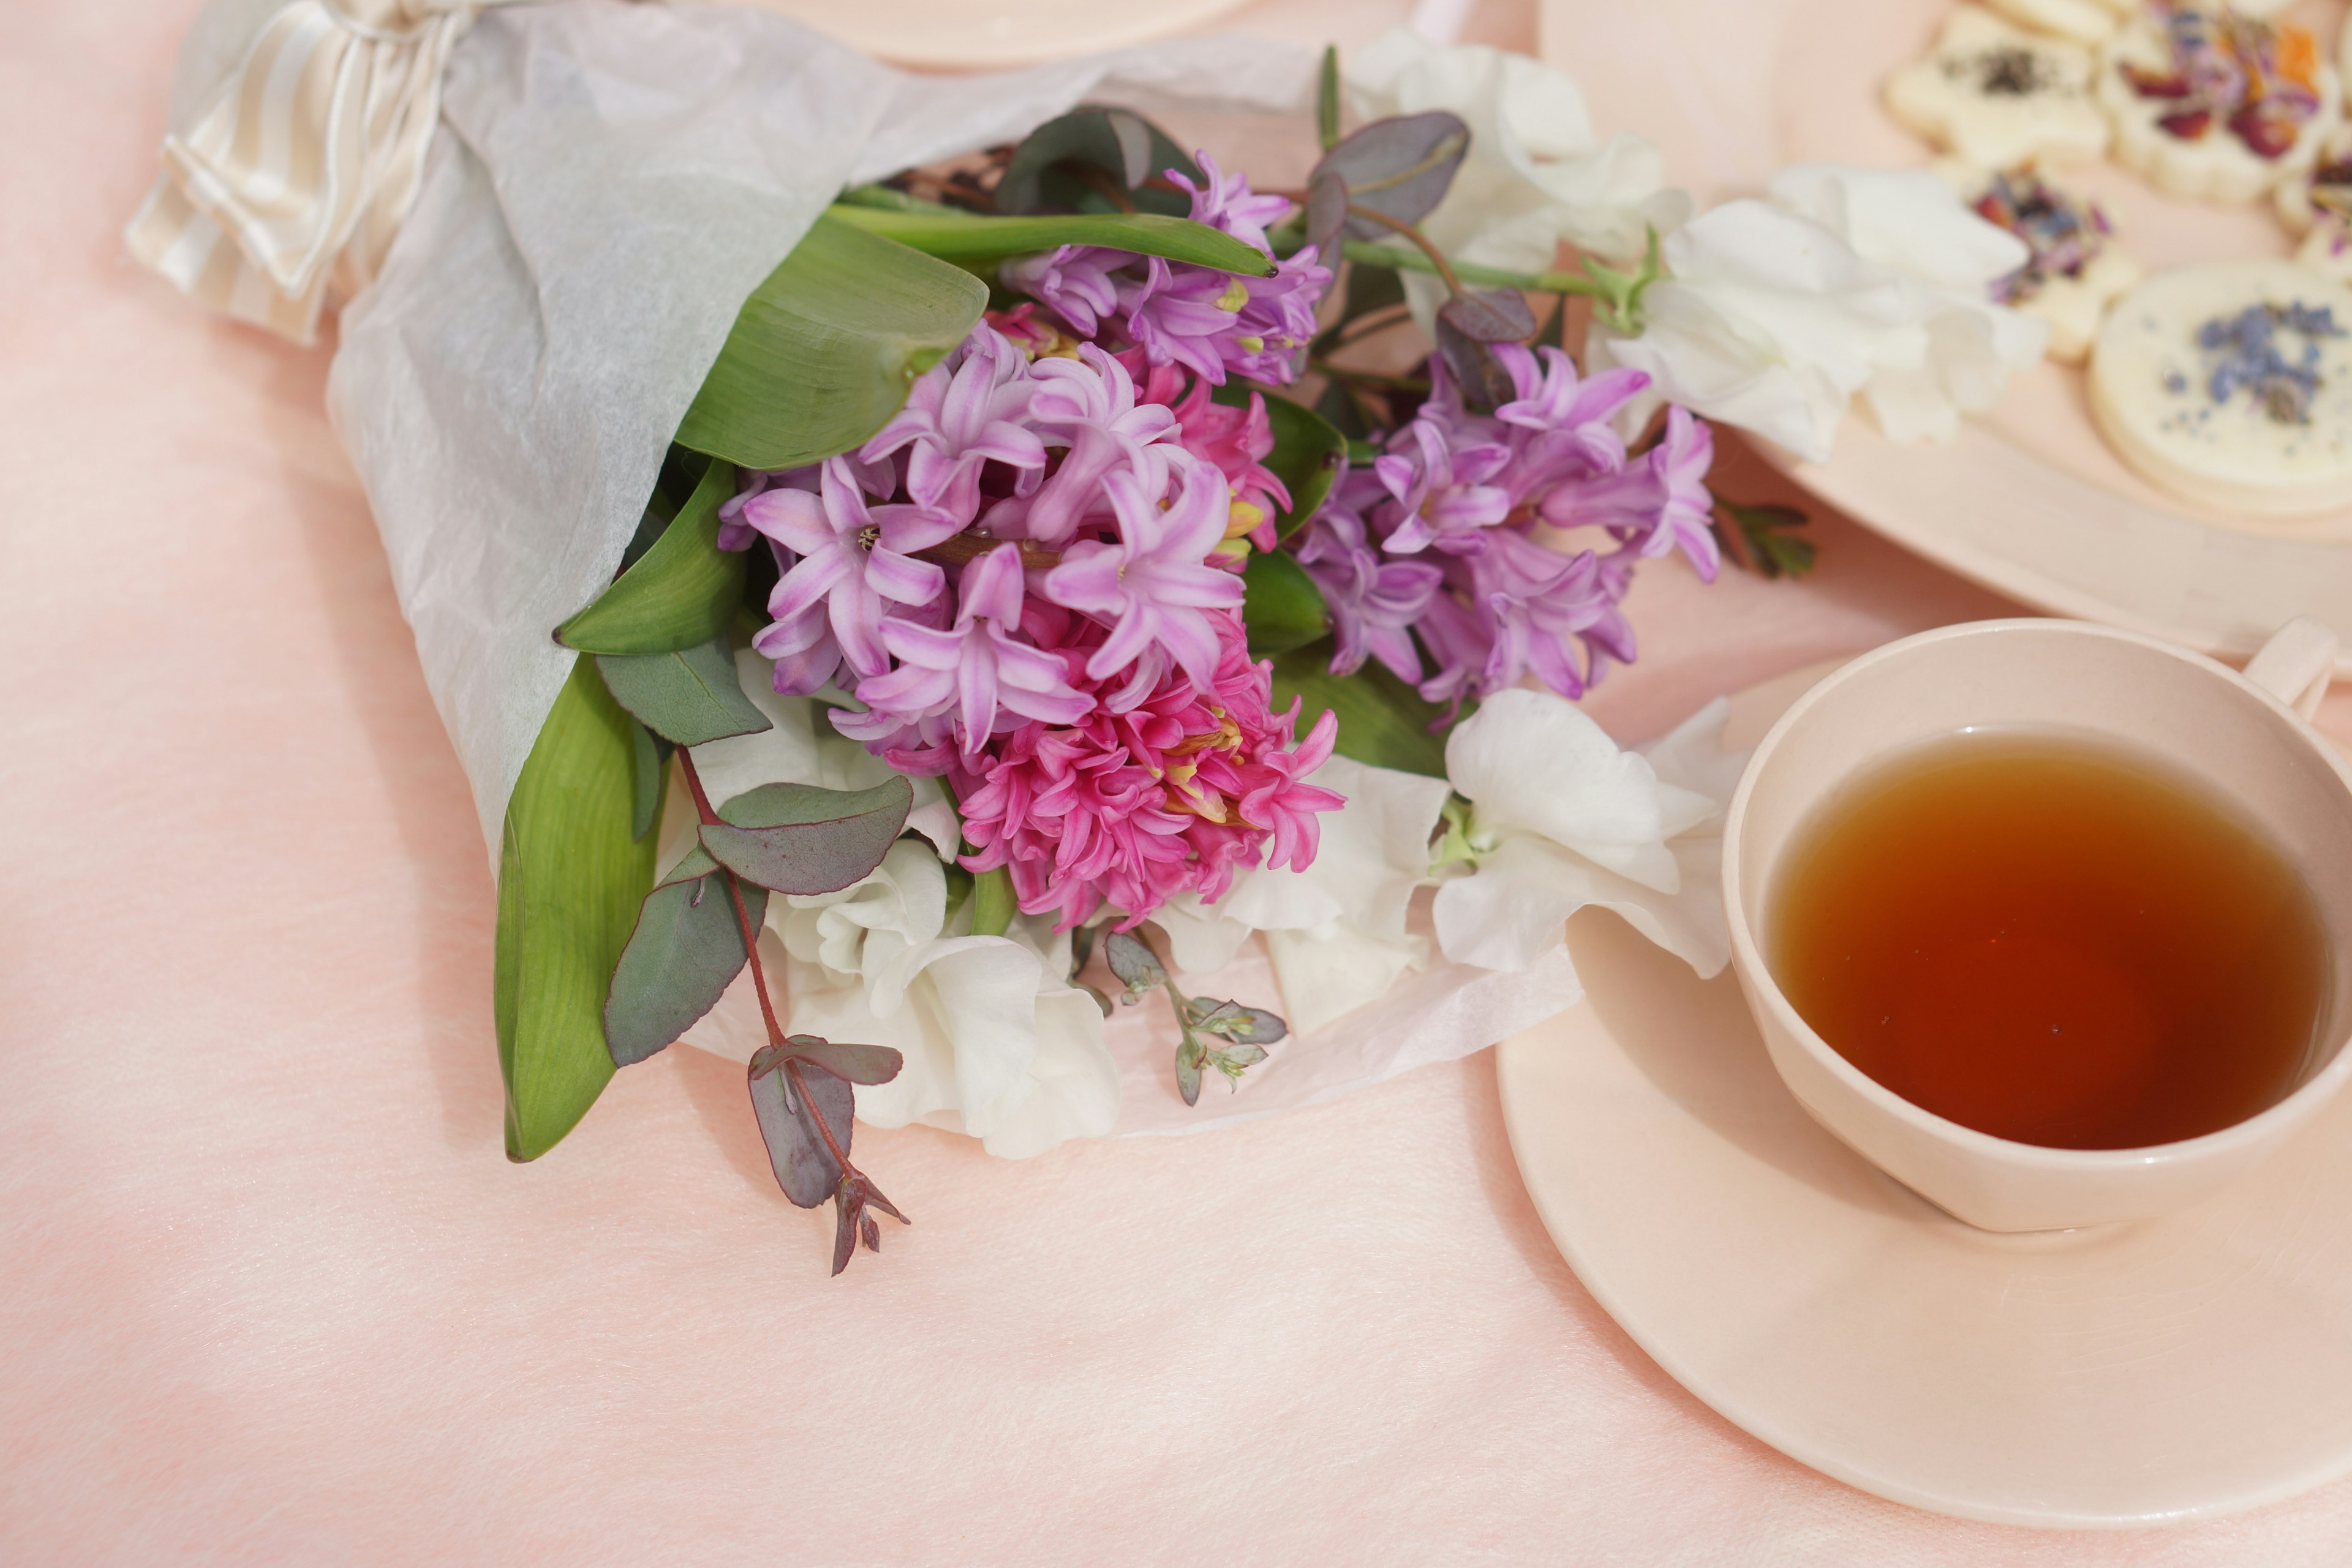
[125,0,524,343]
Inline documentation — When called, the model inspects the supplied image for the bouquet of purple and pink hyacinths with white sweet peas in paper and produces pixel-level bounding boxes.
[132,0,2060,1272]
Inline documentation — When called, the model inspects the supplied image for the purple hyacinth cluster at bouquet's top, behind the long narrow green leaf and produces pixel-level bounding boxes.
[1005,153,1331,385]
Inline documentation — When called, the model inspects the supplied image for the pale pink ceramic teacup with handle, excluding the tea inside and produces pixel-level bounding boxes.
[1724,620,2352,1232]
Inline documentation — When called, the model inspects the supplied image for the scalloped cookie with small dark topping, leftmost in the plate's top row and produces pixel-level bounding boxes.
[1887,5,2108,169]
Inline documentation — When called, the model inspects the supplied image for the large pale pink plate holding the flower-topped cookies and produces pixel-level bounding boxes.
[1543,0,2352,675]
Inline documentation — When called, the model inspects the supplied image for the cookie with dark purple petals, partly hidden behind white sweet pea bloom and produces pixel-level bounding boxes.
[1936,160,2140,364]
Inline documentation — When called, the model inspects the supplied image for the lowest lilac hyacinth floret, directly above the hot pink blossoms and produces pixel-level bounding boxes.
[835,543,1094,757]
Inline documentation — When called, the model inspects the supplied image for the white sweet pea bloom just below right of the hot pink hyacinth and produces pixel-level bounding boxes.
[1153,757,1449,1035]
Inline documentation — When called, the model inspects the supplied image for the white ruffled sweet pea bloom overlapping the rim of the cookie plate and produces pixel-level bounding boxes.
[1595,165,2049,463]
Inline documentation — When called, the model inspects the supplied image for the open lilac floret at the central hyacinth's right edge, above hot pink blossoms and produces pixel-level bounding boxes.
[1044,458,1242,691]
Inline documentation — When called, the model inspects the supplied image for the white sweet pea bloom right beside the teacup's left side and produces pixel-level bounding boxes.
[1433,691,1741,976]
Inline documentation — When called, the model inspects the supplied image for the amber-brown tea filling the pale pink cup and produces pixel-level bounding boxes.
[1771,731,2331,1150]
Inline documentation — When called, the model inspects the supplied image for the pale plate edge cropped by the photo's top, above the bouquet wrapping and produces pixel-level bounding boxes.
[753,0,1246,70]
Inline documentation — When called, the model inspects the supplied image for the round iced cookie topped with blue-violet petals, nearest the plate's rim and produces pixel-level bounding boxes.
[2091,261,2352,517]
